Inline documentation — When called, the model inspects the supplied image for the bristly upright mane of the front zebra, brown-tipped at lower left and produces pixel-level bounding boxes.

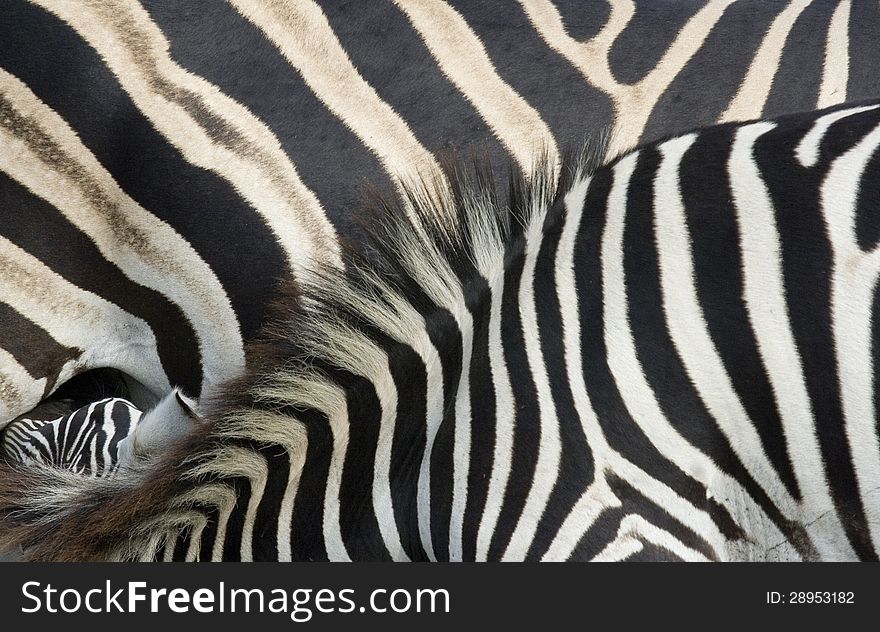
[0,136,607,560]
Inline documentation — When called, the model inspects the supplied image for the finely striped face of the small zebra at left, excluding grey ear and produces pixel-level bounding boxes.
[0,397,142,476]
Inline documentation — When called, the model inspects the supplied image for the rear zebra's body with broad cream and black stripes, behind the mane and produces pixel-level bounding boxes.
[0,0,880,426]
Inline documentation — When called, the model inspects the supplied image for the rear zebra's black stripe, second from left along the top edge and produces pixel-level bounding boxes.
[143,0,390,244]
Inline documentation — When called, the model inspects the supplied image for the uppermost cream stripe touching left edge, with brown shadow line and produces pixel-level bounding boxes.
[0,70,244,392]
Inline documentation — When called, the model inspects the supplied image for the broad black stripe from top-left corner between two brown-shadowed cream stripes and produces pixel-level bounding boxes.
[0,0,285,346]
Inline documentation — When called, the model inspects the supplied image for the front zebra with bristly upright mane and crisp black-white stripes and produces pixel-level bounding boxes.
[0,101,880,561]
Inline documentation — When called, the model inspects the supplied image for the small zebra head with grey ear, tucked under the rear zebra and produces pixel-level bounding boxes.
[0,389,199,476]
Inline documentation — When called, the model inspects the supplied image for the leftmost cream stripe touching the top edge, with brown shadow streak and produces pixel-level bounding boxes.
[36,0,340,274]
